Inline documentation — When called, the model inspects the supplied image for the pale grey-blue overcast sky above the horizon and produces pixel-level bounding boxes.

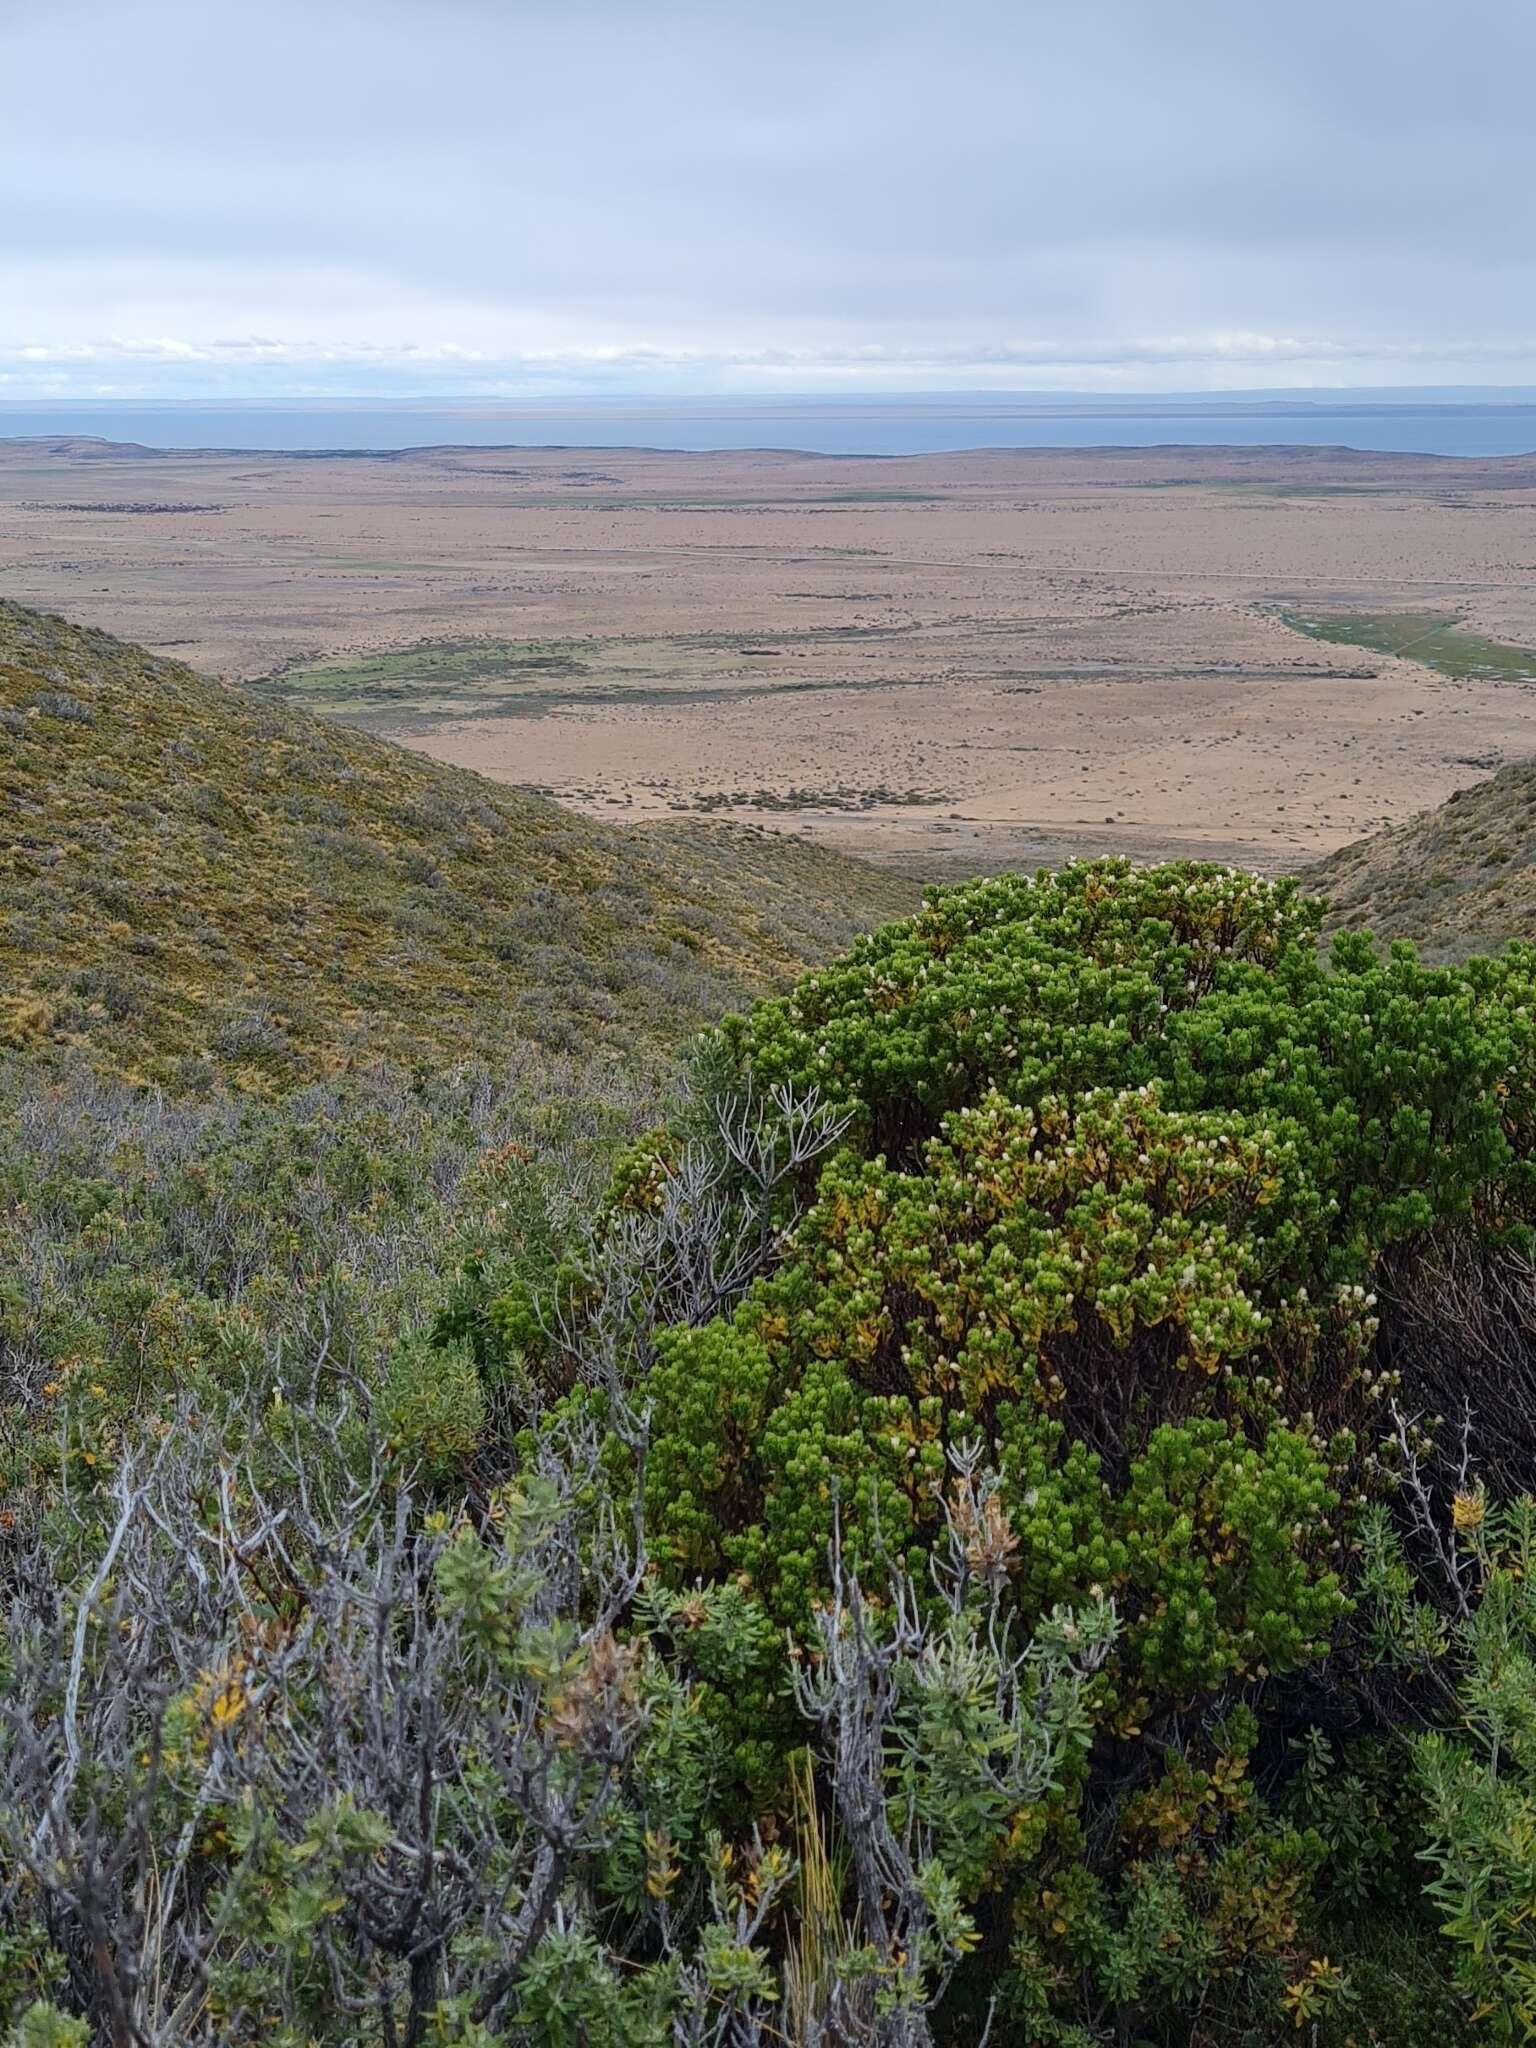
[0,0,1536,397]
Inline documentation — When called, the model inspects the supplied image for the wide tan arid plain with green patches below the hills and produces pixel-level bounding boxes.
[0,440,1536,872]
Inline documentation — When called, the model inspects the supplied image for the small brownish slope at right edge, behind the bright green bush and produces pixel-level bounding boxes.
[1303,760,1536,961]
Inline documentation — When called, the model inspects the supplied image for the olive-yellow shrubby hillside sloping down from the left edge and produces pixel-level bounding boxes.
[0,602,915,1090]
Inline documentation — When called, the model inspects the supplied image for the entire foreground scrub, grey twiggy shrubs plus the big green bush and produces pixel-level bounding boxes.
[0,835,1536,2048]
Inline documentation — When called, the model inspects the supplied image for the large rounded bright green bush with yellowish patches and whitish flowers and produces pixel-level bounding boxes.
[647,862,1536,1662]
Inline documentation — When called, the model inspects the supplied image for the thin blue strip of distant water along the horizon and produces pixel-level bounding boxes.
[0,389,1536,455]
